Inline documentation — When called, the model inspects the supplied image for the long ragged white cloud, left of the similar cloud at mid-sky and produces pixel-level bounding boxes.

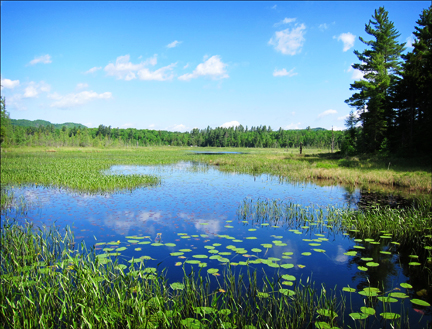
[104,54,176,81]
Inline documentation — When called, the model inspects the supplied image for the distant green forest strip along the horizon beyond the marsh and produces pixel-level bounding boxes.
[2,116,343,150]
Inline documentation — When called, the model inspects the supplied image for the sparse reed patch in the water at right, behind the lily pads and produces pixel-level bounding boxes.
[237,199,432,243]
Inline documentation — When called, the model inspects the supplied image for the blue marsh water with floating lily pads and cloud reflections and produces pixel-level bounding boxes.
[3,162,431,327]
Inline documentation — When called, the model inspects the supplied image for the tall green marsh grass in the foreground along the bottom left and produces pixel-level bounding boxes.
[0,221,422,329]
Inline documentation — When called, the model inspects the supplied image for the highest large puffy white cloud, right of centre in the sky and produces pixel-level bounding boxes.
[268,24,306,55]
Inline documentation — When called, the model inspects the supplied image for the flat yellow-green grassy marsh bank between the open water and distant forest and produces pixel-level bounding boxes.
[1,147,432,193]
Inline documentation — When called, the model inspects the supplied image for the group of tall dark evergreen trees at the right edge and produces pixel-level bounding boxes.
[342,6,432,155]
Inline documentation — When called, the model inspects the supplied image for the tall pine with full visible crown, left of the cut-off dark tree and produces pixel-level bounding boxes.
[345,7,405,152]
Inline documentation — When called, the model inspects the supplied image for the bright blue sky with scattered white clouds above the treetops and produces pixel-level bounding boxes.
[1,1,430,132]
